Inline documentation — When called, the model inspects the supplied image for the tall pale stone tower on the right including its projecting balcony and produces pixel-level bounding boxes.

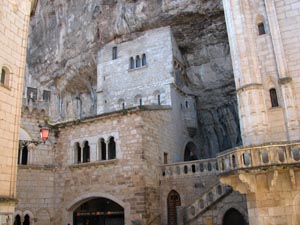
[218,0,300,225]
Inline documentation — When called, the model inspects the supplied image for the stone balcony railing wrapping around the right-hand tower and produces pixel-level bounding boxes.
[217,142,300,174]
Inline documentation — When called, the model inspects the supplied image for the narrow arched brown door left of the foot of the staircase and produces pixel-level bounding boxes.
[167,190,181,225]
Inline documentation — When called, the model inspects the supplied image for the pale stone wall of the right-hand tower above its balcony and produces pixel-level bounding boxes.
[223,0,300,145]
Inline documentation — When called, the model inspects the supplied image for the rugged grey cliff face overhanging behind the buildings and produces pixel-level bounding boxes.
[26,0,241,157]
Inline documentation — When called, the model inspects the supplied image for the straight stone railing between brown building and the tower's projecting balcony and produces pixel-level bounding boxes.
[161,159,218,179]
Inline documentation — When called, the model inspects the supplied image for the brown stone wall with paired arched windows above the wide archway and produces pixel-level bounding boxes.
[51,110,177,224]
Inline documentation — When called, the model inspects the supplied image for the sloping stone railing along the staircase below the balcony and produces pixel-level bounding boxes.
[182,183,232,224]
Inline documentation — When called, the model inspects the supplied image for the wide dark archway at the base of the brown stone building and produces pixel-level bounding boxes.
[73,198,125,225]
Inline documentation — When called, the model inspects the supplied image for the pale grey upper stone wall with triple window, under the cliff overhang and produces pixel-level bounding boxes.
[97,27,174,114]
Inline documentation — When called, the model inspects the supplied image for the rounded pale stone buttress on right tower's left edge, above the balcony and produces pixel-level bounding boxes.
[223,0,269,145]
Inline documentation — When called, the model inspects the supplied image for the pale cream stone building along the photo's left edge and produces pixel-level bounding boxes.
[0,0,34,224]
